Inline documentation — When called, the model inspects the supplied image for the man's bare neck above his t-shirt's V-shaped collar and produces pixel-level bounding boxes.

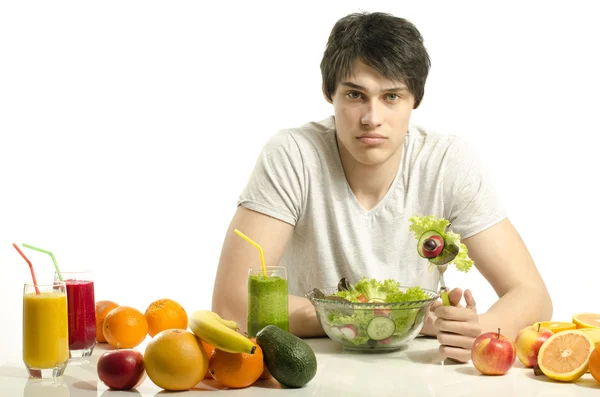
[338,143,402,211]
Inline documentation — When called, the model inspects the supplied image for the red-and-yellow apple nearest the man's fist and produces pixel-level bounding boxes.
[471,329,517,375]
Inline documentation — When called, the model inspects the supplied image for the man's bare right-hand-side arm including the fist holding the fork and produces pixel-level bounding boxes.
[432,219,552,362]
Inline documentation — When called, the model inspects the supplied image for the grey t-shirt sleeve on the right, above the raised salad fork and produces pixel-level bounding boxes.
[443,138,506,238]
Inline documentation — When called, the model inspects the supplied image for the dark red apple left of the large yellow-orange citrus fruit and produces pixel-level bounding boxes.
[97,349,146,390]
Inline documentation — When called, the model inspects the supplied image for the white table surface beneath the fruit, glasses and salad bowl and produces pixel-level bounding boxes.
[0,338,600,397]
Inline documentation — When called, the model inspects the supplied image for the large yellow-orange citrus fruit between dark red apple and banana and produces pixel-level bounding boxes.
[144,329,208,391]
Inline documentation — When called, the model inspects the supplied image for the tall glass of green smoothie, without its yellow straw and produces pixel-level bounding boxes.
[248,266,289,337]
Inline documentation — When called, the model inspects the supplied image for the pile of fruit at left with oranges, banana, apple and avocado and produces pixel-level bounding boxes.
[96,299,317,391]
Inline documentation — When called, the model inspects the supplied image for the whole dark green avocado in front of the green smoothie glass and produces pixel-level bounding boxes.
[256,325,317,388]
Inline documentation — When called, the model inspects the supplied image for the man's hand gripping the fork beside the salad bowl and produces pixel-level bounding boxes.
[434,288,481,362]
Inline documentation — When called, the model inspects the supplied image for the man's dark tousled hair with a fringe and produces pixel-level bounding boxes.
[321,12,431,109]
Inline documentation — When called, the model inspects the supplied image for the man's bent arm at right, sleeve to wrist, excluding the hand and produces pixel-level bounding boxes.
[464,219,552,339]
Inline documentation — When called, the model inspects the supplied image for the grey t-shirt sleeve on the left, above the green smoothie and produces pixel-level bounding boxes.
[238,130,305,225]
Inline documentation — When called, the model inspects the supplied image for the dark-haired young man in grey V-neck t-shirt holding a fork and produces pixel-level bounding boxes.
[213,13,552,362]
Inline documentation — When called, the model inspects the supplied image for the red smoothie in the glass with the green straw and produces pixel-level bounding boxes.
[65,280,96,350]
